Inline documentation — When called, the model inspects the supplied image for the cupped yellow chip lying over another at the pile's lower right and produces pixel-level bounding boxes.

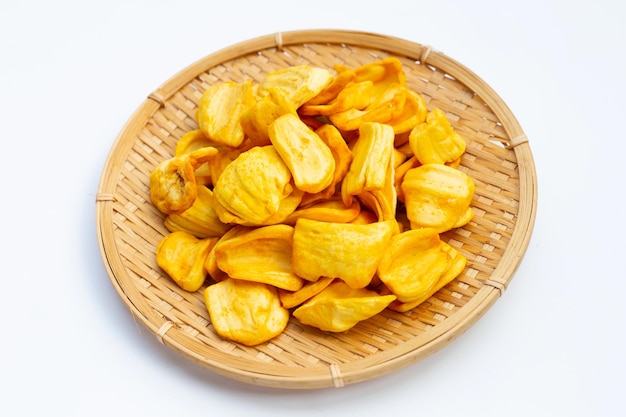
[378,228,451,303]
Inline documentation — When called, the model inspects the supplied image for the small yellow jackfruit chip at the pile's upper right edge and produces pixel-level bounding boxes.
[409,109,465,164]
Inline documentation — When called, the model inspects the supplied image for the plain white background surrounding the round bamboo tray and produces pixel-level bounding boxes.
[0,0,626,417]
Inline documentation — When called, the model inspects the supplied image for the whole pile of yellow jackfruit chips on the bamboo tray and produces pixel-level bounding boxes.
[150,58,474,346]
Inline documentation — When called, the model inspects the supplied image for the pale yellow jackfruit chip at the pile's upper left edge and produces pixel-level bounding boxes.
[196,80,254,147]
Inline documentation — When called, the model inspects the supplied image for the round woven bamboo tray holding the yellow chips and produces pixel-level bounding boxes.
[96,30,537,389]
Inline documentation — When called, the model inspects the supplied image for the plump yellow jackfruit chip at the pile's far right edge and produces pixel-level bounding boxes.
[401,164,475,233]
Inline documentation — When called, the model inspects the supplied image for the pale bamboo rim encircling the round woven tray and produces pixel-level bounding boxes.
[96,29,537,389]
